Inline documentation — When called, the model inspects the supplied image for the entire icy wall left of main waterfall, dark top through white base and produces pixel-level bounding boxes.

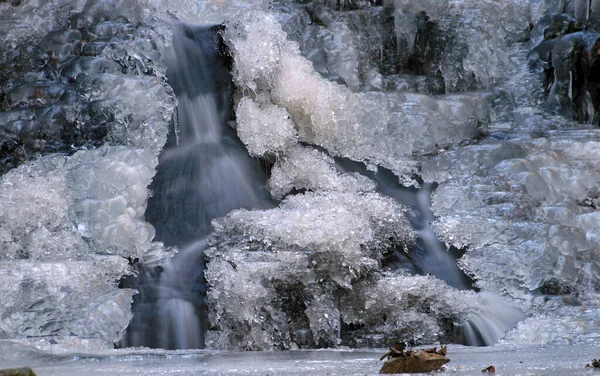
[0,0,176,347]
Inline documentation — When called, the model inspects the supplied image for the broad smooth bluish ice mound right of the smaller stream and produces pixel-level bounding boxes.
[424,130,600,312]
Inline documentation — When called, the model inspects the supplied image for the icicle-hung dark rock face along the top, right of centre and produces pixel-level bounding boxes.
[278,0,530,91]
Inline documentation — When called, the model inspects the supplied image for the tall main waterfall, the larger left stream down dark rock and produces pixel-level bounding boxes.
[122,25,270,349]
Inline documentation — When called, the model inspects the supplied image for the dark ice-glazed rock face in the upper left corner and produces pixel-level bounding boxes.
[0,1,175,171]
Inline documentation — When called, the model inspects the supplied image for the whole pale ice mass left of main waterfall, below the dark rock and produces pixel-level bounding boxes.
[0,146,167,343]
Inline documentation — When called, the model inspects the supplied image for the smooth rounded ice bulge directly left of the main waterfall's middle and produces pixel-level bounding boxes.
[67,146,158,257]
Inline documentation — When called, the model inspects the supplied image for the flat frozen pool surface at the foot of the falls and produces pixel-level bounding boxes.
[0,345,600,376]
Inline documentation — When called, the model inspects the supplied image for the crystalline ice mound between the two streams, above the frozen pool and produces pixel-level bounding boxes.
[206,192,490,349]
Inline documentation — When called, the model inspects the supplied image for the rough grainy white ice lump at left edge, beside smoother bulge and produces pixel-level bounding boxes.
[0,156,88,262]
